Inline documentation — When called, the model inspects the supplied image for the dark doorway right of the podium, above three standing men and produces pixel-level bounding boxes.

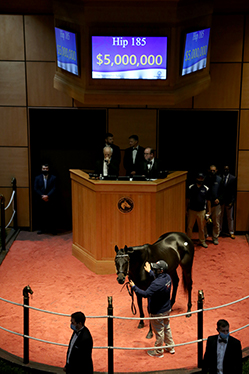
[159,110,238,183]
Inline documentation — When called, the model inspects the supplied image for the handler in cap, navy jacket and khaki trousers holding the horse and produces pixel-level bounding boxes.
[130,260,175,358]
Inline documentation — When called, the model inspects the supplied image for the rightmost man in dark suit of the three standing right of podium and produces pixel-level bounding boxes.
[220,166,237,239]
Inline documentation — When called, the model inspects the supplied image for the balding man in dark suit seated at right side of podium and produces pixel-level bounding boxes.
[139,148,163,179]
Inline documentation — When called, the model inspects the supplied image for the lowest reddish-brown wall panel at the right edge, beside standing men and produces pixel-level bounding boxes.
[236,192,249,232]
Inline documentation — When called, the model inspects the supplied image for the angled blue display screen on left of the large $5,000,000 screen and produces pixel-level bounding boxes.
[55,27,79,75]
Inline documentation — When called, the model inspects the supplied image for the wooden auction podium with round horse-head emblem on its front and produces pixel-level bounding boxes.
[70,170,187,274]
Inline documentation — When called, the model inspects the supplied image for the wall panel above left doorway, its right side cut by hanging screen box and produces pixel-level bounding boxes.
[27,62,72,107]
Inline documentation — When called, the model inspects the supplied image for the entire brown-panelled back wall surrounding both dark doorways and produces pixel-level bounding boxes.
[0,14,249,231]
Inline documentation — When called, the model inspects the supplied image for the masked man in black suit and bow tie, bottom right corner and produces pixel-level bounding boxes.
[202,319,242,374]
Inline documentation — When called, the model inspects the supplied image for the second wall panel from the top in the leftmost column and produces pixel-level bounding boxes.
[0,61,26,106]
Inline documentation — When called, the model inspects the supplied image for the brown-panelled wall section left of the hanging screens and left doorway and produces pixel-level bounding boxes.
[0,15,72,227]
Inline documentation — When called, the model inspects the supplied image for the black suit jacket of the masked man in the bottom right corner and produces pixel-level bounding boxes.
[202,335,242,374]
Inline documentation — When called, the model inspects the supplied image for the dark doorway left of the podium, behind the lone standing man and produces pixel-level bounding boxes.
[29,108,106,231]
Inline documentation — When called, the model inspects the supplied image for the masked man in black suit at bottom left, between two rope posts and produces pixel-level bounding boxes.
[63,312,93,374]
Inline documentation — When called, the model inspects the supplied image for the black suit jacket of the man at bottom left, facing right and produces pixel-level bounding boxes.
[66,326,93,374]
